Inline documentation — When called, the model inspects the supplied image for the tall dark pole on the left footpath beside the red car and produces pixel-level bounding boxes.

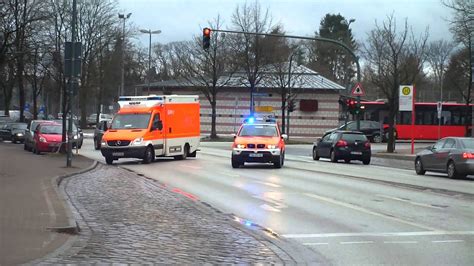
[67,0,77,167]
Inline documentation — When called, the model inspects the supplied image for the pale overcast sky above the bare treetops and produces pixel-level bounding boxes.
[119,0,452,47]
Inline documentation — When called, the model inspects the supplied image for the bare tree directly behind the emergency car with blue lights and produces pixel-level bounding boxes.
[232,1,273,112]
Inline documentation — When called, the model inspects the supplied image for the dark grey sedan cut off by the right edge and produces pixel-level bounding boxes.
[415,137,474,178]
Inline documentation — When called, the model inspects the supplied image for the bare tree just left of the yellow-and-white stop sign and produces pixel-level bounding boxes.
[364,14,428,152]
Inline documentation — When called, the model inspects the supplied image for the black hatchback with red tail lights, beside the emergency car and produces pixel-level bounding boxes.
[313,130,372,164]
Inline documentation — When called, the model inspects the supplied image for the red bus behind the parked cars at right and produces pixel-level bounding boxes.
[362,101,474,140]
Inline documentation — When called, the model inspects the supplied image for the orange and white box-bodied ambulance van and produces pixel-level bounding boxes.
[101,95,200,164]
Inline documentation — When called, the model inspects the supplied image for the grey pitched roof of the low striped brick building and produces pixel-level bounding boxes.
[137,62,345,90]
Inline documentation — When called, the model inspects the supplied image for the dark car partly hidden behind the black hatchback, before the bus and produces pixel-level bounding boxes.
[325,120,397,143]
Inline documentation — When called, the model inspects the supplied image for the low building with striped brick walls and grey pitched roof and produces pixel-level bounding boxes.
[137,66,344,138]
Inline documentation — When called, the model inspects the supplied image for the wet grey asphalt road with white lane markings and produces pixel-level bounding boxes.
[76,139,474,265]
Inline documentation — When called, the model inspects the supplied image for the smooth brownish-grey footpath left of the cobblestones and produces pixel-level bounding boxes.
[0,142,93,266]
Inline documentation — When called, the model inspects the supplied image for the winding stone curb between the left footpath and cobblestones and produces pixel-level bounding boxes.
[46,161,97,235]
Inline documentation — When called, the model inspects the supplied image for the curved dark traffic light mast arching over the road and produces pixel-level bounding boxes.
[206,28,361,127]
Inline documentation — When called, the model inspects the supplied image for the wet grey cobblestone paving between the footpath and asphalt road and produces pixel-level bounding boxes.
[42,165,295,264]
